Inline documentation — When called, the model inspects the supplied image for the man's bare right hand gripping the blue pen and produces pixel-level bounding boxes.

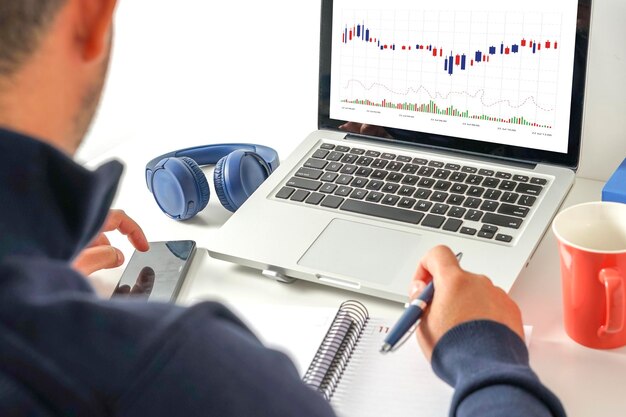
[411,246,524,360]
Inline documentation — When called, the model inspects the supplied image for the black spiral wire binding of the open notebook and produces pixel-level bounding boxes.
[302,300,369,401]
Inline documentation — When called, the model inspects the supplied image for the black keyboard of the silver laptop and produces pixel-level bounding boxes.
[275,143,548,243]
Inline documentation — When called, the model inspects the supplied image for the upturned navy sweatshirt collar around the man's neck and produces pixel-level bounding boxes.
[0,128,123,260]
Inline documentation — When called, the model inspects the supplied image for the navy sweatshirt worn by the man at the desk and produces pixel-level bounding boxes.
[0,129,564,417]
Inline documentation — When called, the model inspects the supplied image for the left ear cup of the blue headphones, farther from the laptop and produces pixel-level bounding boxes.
[152,157,209,220]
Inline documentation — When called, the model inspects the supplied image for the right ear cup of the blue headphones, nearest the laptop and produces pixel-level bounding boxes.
[213,150,271,212]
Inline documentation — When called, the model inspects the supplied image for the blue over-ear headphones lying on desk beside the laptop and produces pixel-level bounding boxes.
[146,143,280,220]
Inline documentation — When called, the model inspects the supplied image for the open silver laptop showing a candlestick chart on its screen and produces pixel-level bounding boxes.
[208,0,591,302]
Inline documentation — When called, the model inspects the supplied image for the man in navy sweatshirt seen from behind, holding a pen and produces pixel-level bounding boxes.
[0,0,564,417]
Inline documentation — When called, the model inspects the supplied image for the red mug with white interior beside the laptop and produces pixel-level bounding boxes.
[552,201,626,349]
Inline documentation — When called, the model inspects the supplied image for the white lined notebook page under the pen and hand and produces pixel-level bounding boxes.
[331,319,453,417]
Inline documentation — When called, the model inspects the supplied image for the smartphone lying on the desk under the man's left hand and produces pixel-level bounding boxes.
[112,240,196,302]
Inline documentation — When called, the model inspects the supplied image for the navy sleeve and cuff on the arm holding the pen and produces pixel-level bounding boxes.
[432,320,565,417]
